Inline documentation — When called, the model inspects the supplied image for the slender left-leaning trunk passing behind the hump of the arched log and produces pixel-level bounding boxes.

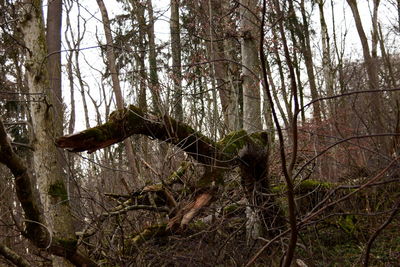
[97,0,139,186]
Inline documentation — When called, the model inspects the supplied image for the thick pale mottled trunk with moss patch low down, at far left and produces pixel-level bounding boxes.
[21,1,75,266]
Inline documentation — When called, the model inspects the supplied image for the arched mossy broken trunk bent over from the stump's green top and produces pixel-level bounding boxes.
[56,105,267,167]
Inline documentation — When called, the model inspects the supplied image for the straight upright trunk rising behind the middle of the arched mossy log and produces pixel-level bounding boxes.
[170,0,183,121]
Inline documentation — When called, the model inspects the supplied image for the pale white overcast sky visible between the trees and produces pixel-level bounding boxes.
[54,0,398,131]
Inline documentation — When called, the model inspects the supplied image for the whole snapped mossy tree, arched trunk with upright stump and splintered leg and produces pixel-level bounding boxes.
[56,105,273,234]
